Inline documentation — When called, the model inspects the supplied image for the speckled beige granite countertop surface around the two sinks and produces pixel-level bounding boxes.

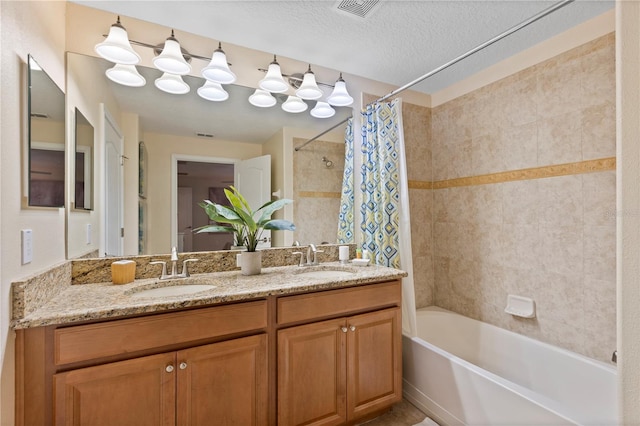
[12,262,407,329]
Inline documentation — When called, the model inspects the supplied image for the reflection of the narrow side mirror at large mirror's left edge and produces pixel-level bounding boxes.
[73,108,94,210]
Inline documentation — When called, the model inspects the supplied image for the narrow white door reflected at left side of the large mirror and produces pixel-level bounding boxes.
[105,114,124,256]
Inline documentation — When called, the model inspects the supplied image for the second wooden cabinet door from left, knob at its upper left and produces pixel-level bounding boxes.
[177,334,268,426]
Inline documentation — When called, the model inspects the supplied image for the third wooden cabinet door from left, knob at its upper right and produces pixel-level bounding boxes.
[278,319,347,426]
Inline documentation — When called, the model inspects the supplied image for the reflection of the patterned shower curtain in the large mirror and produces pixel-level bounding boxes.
[338,118,354,244]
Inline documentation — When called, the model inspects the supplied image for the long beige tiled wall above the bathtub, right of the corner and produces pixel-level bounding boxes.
[432,33,616,362]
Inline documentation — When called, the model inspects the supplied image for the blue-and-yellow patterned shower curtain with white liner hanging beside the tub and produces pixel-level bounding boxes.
[360,98,416,337]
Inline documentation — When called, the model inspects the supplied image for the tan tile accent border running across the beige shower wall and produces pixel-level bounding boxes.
[409,157,616,189]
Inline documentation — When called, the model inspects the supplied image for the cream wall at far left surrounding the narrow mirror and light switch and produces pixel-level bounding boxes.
[0,1,66,425]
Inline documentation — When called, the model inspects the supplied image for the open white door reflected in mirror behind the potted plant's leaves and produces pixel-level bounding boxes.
[234,155,271,249]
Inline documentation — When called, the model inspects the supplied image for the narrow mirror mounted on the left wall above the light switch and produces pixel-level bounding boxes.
[27,55,65,207]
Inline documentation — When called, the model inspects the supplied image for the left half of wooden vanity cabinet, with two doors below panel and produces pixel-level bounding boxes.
[16,300,269,426]
